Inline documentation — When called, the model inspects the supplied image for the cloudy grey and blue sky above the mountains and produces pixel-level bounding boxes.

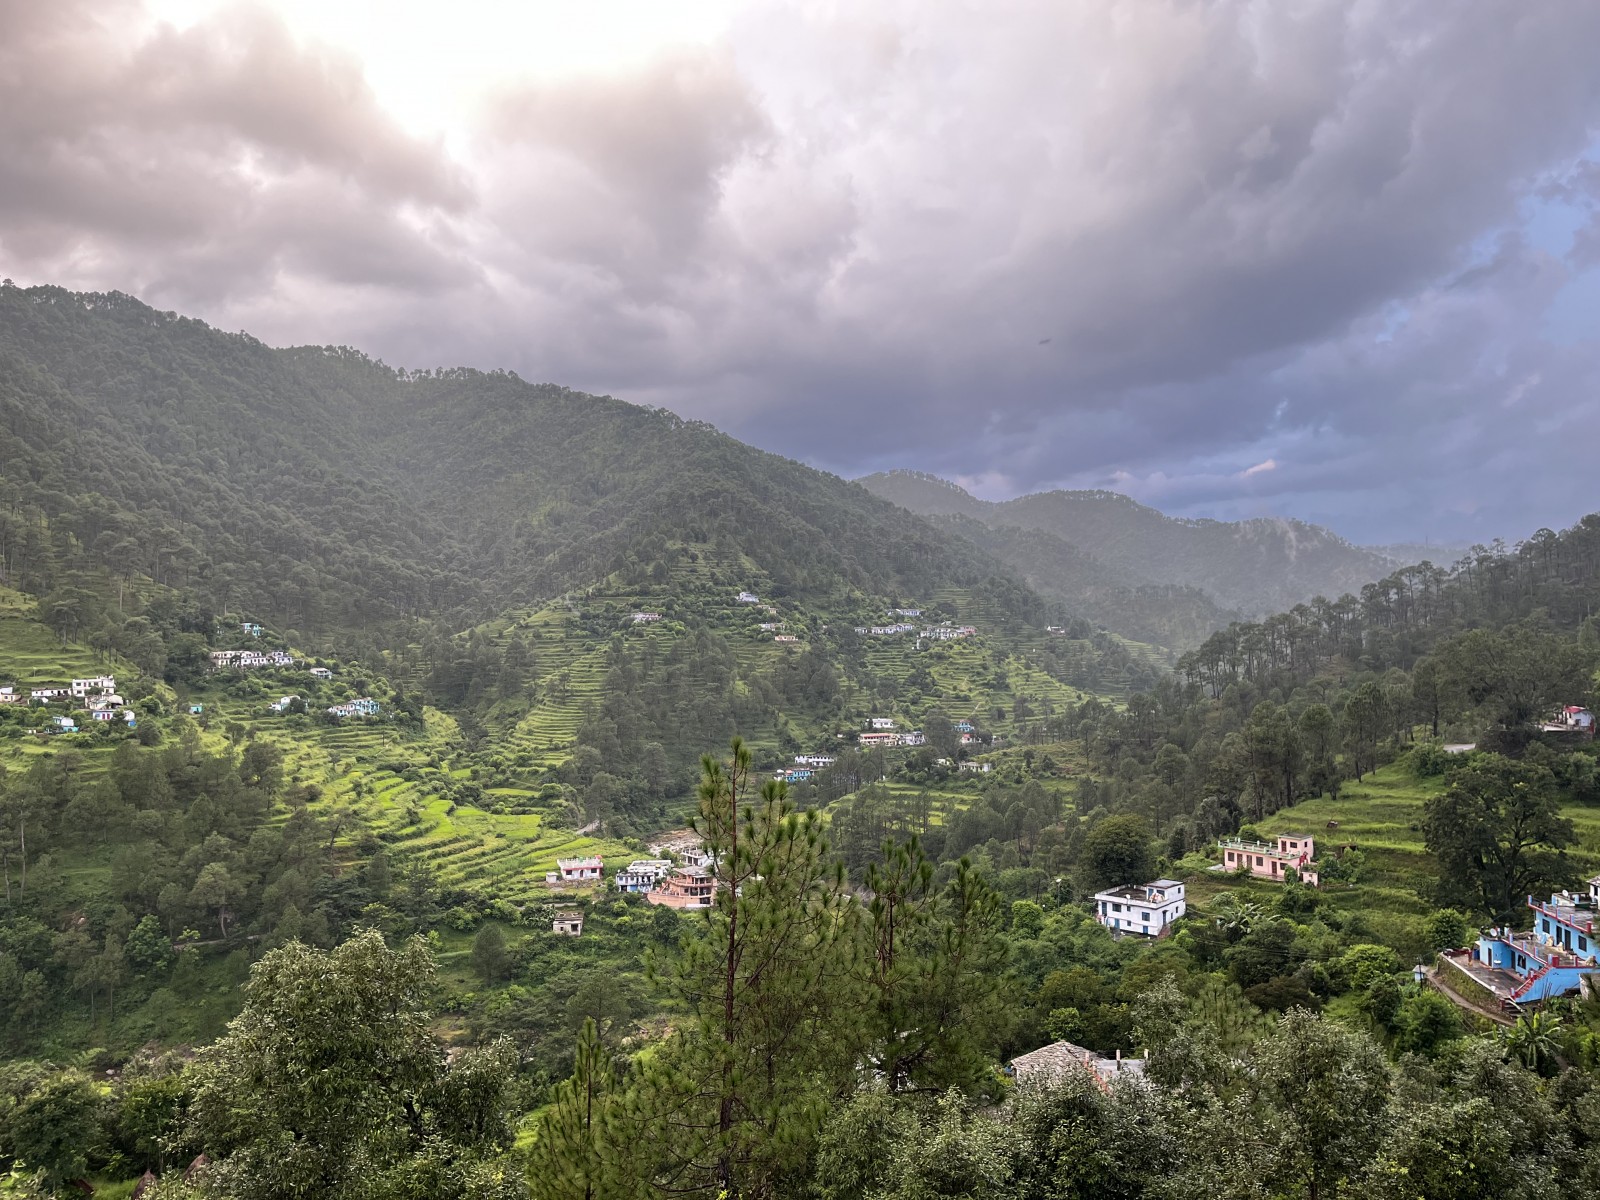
[0,0,1600,541]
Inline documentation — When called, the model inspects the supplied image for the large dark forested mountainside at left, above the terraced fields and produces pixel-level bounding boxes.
[0,286,1043,632]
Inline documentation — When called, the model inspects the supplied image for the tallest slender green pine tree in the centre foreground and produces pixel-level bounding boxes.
[627,739,866,1200]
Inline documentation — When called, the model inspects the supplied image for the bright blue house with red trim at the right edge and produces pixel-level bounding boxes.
[1472,877,1600,1005]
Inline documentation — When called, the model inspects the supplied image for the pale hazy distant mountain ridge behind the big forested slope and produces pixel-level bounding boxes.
[858,470,1394,613]
